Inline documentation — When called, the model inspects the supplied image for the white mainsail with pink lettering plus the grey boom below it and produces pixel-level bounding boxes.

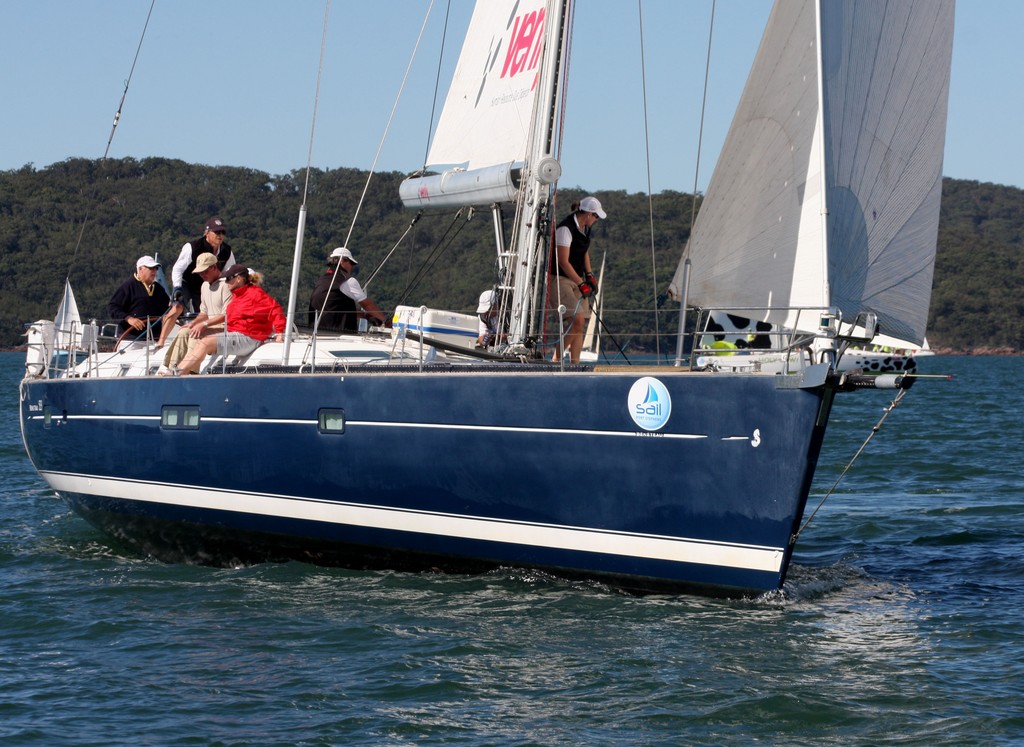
[400,0,546,207]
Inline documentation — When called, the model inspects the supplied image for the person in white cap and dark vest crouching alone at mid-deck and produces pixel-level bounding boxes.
[307,246,387,332]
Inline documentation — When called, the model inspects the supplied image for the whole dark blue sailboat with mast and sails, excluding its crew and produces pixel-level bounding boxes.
[20,0,953,595]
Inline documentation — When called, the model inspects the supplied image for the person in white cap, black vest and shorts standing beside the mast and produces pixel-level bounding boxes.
[548,197,607,363]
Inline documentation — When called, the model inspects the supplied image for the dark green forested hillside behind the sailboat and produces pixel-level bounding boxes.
[0,158,1024,351]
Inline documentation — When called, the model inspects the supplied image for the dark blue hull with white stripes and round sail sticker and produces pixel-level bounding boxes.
[22,367,827,593]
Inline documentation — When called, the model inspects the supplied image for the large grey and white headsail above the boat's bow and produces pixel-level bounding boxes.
[670,0,953,343]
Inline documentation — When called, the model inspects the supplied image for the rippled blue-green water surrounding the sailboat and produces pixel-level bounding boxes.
[0,354,1024,746]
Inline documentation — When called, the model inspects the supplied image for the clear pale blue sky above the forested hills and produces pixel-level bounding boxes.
[0,0,1024,192]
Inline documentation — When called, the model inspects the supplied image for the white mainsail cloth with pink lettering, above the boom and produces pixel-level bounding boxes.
[427,0,545,169]
